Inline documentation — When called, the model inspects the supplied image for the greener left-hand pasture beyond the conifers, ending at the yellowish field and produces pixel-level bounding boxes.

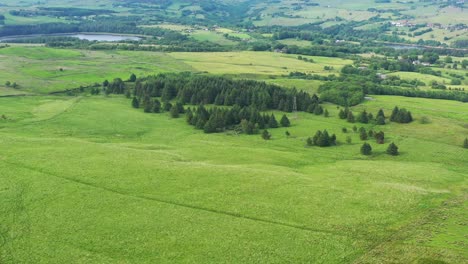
[0,46,191,93]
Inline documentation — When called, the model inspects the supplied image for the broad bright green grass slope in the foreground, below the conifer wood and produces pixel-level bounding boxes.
[0,96,468,263]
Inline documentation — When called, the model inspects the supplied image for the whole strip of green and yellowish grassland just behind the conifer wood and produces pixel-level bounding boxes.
[0,46,352,93]
